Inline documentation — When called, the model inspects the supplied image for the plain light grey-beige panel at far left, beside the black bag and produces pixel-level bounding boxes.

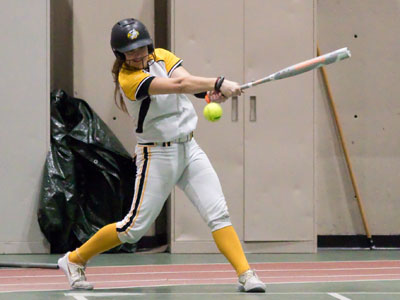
[0,0,50,253]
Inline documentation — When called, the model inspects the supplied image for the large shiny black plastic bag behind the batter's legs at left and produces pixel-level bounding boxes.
[38,90,136,253]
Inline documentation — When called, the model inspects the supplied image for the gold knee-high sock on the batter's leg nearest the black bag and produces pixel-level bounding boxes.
[68,223,122,265]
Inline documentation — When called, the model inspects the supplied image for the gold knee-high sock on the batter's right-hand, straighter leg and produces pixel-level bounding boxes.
[212,226,250,275]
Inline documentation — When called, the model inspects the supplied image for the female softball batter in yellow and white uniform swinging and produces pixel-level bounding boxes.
[58,19,265,292]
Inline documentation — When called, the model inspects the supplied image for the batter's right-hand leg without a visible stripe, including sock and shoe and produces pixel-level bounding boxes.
[178,140,265,292]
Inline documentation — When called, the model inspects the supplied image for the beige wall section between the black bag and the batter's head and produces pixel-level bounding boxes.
[73,0,154,154]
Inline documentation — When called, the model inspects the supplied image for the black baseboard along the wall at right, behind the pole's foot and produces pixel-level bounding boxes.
[318,235,400,249]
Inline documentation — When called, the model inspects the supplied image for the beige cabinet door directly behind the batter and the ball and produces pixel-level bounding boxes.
[171,0,244,248]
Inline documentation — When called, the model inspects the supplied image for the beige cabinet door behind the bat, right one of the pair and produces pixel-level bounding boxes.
[244,0,315,241]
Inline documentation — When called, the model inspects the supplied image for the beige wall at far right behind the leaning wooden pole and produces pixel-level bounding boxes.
[315,0,400,235]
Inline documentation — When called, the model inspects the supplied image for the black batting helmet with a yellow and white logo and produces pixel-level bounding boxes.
[111,18,154,60]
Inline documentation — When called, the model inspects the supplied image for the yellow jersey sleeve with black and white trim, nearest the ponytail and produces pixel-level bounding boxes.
[118,68,154,101]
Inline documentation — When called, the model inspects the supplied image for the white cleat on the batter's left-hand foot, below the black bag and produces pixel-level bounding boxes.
[58,252,93,290]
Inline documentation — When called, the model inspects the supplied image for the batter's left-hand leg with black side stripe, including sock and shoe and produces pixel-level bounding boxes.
[58,146,177,289]
